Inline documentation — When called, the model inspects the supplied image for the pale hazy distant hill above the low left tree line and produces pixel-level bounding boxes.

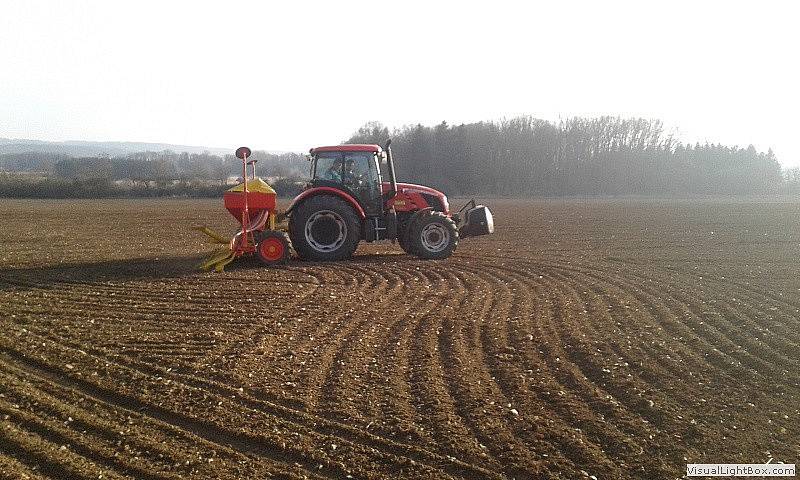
[0,138,285,157]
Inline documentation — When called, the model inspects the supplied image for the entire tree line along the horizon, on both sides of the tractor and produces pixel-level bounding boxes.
[0,117,800,198]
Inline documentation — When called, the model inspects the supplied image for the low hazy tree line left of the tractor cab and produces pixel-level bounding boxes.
[0,150,308,198]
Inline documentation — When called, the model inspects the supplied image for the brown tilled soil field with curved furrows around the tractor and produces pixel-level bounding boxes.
[0,200,800,479]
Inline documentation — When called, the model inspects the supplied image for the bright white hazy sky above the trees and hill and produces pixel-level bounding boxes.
[0,0,800,165]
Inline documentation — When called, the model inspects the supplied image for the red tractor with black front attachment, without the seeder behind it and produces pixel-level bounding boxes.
[286,141,494,260]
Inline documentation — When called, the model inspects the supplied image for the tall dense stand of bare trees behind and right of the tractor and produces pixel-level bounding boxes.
[347,117,800,196]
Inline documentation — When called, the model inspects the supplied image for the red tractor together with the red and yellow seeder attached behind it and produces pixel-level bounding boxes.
[195,141,494,271]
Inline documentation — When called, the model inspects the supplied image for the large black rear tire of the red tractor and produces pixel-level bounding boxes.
[289,195,361,261]
